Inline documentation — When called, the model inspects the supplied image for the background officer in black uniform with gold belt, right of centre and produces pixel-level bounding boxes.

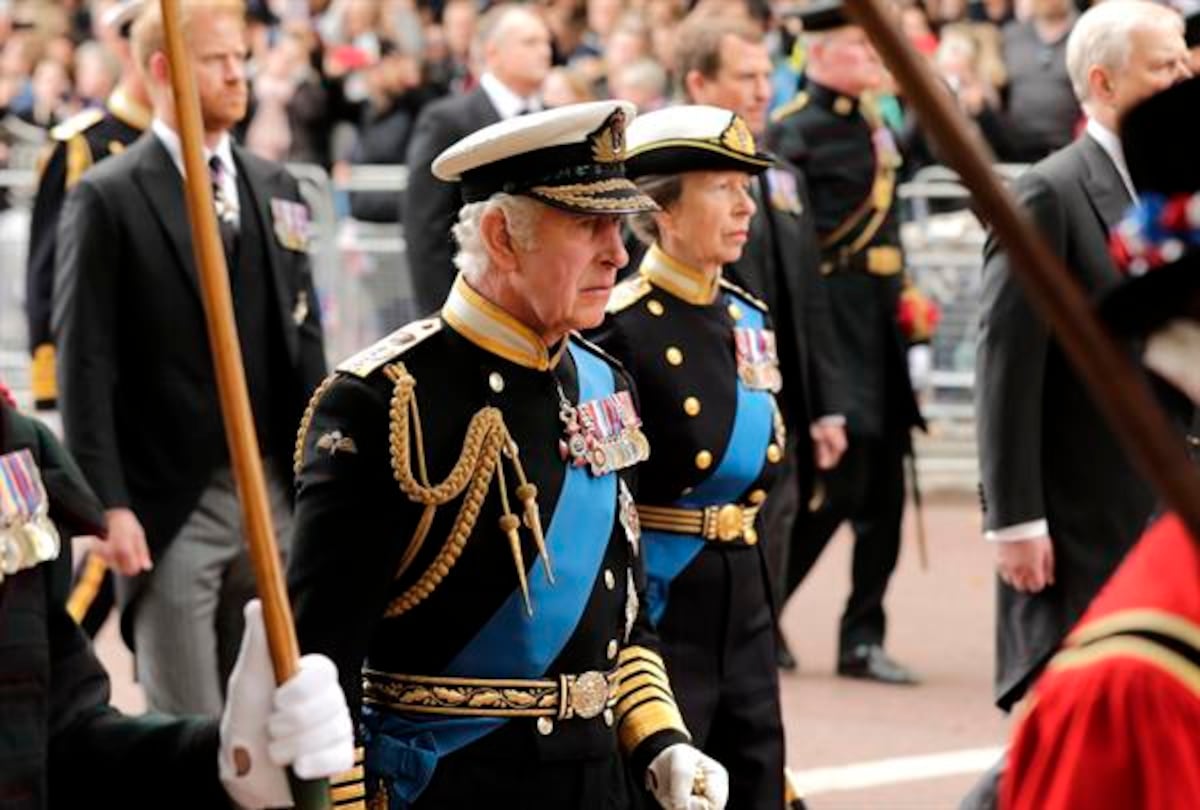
[768,2,928,683]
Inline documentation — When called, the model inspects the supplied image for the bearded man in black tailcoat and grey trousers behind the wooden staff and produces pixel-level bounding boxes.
[54,0,324,714]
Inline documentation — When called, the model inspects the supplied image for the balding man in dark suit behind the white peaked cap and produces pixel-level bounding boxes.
[401,5,551,316]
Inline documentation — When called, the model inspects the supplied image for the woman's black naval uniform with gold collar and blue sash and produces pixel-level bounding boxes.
[596,246,785,808]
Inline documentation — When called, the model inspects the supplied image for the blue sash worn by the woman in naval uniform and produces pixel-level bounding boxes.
[642,293,774,624]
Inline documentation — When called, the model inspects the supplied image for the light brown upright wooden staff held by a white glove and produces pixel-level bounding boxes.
[160,0,330,810]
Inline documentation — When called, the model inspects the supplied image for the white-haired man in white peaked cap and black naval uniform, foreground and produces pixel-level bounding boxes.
[289,102,727,810]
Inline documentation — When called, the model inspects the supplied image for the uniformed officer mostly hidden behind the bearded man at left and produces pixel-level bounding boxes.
[25,0,150,636]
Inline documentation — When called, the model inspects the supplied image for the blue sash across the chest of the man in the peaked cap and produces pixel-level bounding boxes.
[362,344,617,810]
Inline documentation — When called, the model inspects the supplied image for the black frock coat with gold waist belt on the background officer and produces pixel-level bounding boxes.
[767,80,924,437]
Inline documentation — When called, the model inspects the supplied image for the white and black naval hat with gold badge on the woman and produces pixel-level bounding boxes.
[625,104,774,178]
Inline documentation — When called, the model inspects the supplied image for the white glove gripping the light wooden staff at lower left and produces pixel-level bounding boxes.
[217,599,354,810]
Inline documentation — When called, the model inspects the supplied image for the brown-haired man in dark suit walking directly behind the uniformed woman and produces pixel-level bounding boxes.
[676,14,846,668]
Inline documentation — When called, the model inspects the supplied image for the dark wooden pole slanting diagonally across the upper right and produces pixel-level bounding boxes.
[845,0,1200,544]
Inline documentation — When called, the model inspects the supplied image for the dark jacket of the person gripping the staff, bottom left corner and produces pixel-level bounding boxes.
[0,401,230,810]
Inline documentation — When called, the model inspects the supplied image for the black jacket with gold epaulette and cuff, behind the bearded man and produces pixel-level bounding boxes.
[25,90,150,408]
